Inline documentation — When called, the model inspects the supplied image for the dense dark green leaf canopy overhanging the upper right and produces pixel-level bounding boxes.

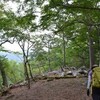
[36,0,100,66]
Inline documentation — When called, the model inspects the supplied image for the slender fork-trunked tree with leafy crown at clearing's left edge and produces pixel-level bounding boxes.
[1,1,36,88]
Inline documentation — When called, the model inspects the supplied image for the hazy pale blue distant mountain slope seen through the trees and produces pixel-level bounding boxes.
[0,52,23,62]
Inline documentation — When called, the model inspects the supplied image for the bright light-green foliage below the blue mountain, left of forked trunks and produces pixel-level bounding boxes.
[0,56,24,86]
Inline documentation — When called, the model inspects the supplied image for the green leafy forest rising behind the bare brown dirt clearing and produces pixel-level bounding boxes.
[0,0,100,99]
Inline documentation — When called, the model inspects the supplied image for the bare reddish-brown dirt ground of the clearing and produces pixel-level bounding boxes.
[0,78,92,100]
